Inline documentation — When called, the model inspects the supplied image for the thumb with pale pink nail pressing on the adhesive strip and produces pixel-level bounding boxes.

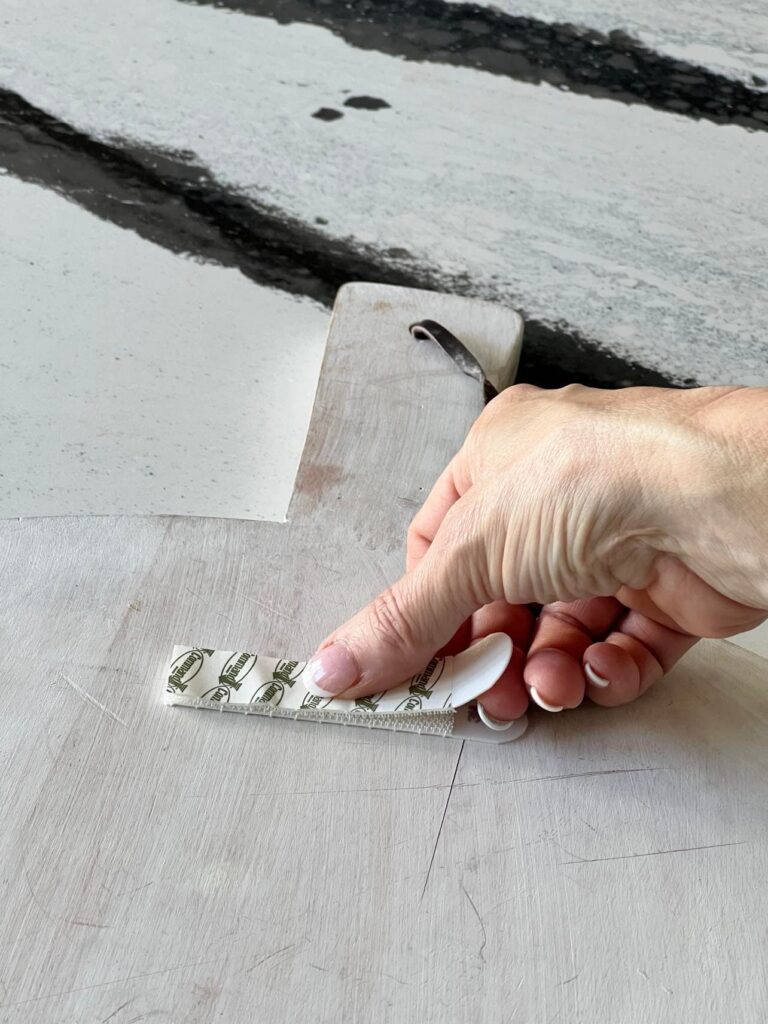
[303,503,488,698]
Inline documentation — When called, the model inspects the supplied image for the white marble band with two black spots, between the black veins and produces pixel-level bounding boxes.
[0,0,768,384]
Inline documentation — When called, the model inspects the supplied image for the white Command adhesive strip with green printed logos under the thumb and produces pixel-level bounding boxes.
[165,633,527,743]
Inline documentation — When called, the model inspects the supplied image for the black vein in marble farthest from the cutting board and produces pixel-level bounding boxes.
[177,0,768,131]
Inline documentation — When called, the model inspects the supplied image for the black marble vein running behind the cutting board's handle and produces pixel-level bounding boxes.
[0,89,694,387]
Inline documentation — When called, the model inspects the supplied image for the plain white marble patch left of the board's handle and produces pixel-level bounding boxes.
[0,176,328,520]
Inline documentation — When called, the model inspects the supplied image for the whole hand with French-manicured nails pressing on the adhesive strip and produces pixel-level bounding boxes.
[307,386,768,724]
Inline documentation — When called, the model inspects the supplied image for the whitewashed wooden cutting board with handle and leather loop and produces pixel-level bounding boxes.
[0,286,768,1024]
